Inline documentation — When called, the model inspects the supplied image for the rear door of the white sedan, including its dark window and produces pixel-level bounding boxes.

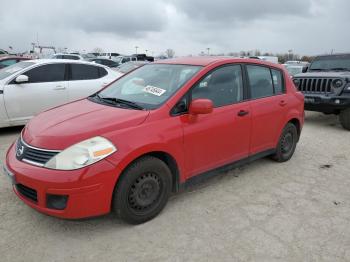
[68,63,110,101]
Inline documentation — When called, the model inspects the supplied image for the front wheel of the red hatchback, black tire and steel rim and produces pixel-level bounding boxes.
[112,156,172,224]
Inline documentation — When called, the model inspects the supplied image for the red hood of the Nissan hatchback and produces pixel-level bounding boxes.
[22,99,149,150]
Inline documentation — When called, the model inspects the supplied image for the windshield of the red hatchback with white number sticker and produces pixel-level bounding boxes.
[98,64,202,109]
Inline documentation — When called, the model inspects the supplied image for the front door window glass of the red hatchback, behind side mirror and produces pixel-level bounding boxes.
[192,65,243,107]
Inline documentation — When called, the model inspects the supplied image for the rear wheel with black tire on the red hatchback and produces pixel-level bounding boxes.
[272,123,298,162]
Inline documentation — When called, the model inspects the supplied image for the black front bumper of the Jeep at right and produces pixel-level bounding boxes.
[304,93,350,113]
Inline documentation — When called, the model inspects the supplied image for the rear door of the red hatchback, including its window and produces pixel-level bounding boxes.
[246,65,288,155]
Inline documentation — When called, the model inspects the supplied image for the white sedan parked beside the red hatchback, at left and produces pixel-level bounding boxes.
[0,59,122,127]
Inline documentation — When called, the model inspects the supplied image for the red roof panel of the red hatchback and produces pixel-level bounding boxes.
[154,56,282,68]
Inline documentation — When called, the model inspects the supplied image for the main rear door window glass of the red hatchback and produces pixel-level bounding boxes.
[247,65,274,99]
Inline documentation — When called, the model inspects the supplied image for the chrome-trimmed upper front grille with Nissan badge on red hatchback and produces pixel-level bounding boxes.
[16,138,59,166]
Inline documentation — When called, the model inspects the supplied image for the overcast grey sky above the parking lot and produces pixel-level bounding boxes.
[0,0,350,56]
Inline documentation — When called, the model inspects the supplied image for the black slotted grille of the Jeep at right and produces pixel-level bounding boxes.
[296,78,334,94]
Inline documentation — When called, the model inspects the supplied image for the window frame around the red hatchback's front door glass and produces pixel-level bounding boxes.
[169,63,249,116]
